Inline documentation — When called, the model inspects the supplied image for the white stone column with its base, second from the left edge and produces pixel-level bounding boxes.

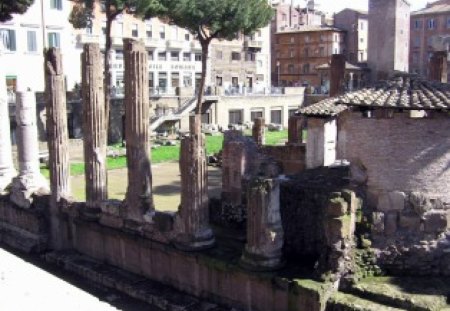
[10,91,49,208]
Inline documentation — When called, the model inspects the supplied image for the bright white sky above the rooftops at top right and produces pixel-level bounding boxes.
[294,0,433,13]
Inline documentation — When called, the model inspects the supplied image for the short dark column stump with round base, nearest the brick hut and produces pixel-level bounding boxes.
[241,178,284,271]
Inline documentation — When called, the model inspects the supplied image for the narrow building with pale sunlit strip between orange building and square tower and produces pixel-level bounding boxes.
[334,9,369,64]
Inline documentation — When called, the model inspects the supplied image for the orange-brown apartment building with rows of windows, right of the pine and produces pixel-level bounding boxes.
[274,26,345,88]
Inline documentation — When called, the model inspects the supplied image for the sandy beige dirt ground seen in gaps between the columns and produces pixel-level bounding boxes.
[71,162,222,211]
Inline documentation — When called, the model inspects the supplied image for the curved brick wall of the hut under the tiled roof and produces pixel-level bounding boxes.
[338,112,450,203]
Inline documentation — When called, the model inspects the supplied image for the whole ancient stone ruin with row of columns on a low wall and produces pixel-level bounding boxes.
[0,39,450,311]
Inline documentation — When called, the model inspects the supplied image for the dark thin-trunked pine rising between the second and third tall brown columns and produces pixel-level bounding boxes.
[69,0,161,141]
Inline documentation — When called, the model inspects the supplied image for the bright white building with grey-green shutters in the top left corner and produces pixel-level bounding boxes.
[0,0,79,92]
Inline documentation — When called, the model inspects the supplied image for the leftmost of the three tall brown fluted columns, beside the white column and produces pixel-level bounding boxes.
[45,48,70,202]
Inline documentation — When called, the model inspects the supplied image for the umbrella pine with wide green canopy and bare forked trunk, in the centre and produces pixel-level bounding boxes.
[146,0,273,131]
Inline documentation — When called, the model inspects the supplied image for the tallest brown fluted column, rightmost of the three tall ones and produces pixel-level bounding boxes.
[123,39,155,222]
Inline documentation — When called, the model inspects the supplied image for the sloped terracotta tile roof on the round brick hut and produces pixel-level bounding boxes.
[299,75,450,116]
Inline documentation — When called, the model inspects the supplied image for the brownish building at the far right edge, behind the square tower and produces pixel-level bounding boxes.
[409,0,450,78]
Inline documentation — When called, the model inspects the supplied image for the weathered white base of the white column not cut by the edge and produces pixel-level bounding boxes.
[10,174,50,208]
